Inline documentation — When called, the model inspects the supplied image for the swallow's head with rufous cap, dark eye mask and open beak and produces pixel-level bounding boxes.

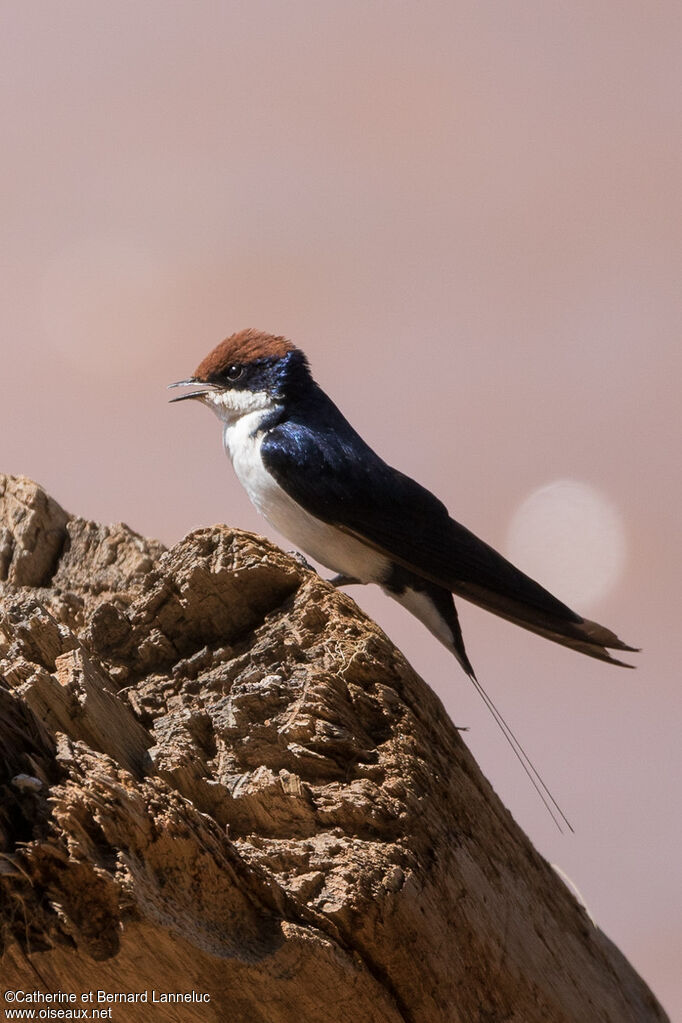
[169,327,310,422]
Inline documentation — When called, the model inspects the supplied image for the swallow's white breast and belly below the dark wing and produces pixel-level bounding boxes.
[223,409,390,582]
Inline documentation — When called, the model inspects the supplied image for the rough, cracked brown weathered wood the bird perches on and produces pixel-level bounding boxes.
[0,477,666,1023]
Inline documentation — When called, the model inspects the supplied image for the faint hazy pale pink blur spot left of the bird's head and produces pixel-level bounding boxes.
[40,234,177,377]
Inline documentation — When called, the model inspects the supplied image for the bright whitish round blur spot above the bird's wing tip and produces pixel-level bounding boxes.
[507,480,627,611]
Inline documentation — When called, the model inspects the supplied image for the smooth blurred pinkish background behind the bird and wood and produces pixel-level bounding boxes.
[0,0,682,1015]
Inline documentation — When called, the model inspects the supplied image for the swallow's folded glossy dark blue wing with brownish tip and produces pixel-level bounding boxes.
[261,392,632,660]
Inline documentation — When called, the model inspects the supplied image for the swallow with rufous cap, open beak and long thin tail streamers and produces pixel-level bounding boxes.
[169,327,637,827]
